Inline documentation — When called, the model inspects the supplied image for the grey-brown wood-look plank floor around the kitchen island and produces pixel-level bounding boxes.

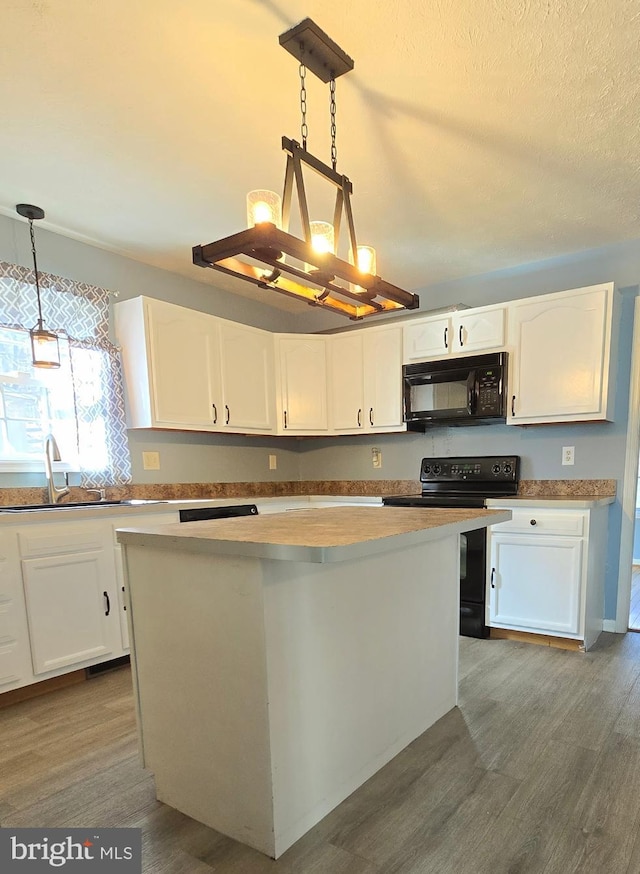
[0,634,640,874]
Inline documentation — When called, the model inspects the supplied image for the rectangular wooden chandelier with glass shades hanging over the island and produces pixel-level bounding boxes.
[193,18,420,319]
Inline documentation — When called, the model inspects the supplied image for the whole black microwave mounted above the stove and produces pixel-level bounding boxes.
[402,352,507,431]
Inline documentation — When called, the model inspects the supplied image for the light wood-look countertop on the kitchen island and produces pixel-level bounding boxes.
[118,507,511,562]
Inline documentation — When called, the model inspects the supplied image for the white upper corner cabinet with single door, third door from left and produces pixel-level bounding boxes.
[276,334,329,436]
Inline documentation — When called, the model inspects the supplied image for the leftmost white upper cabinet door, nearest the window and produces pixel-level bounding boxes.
[146,301,224,430]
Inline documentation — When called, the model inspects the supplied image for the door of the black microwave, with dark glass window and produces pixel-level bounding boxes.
[404,366,475,423]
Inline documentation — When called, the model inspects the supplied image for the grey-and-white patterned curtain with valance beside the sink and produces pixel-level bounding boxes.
[0,261,131,488]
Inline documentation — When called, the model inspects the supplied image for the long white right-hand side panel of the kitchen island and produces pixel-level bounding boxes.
[265,534,460,858]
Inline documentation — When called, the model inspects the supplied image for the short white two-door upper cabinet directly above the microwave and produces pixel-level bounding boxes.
[403,306,505,364]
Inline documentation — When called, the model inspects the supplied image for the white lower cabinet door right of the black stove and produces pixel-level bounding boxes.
[489,534,584,635]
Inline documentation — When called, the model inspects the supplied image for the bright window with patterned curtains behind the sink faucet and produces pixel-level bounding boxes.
[0,262,131,488]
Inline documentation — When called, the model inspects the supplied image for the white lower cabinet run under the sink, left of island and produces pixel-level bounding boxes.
[0,511,178,695]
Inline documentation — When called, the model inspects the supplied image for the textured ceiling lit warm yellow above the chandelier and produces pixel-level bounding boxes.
[0,0,640,312]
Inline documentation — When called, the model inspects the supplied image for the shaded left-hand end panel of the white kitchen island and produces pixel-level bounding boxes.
[125,545,275,856]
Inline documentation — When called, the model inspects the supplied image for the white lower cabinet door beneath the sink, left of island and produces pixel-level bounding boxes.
[22,549,118,674]
